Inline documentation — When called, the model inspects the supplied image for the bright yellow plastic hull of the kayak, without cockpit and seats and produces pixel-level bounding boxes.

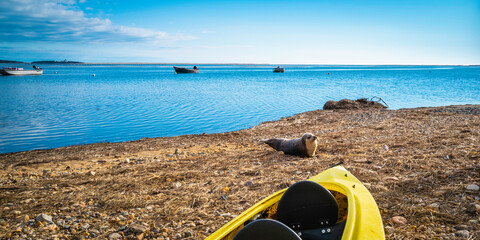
[206,166,385,240]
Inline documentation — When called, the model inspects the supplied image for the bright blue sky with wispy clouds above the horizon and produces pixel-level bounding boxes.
[0,0,480,64]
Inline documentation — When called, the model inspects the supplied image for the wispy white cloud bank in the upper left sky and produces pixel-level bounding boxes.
[0,0,195,44]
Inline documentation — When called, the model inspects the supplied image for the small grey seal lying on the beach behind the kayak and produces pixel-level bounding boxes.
[261,133,317,157]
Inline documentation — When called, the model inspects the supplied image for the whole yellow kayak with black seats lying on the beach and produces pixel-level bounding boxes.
[206,166,385,240]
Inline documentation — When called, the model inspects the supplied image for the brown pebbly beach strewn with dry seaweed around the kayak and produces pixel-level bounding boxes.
[0,105,480,239]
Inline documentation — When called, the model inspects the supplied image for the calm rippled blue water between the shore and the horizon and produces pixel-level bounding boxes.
[0,64,480,153]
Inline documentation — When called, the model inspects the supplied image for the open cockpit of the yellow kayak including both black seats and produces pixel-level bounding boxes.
[219,181,348,240]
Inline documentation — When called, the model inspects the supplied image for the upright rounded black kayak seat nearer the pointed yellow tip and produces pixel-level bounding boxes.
[277,181,344,239]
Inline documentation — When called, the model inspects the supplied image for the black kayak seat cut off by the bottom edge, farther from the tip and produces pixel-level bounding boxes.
[233,219,301,240]
